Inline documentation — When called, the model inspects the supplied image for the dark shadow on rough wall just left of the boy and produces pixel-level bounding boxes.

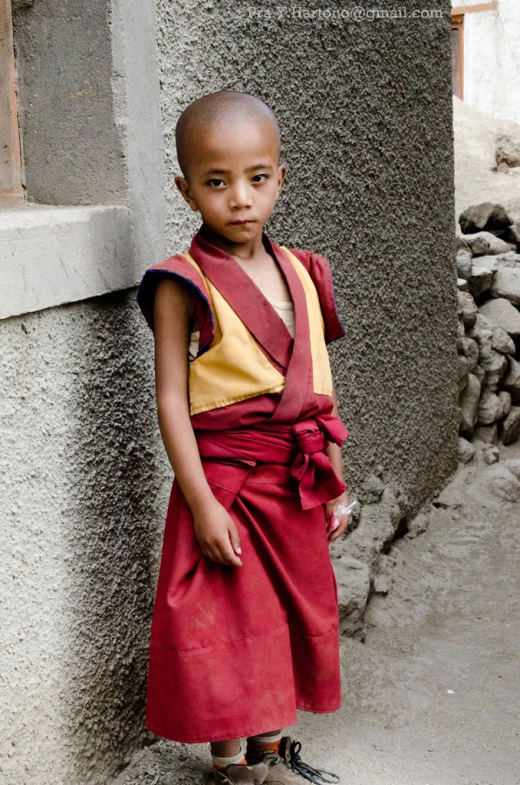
[62,290,168,785]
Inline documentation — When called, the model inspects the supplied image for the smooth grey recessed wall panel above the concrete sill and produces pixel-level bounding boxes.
[13,0,126,205]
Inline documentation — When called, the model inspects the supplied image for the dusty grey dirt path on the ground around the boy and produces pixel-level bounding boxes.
[117,448,520,785]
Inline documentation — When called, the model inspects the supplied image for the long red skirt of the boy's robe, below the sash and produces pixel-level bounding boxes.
[145,462,341,743]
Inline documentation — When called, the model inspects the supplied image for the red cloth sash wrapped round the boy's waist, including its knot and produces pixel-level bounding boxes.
[196,414,348,510]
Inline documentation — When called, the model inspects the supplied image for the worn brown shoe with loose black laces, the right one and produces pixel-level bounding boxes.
[246,736,340,785]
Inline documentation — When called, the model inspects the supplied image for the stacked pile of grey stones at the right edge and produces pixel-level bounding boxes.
[456,202,520,463]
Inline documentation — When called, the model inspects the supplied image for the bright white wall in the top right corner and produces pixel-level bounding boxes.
[452,0,520,123]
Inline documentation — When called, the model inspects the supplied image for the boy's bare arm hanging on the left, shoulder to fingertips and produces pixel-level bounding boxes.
[154,278,242,566]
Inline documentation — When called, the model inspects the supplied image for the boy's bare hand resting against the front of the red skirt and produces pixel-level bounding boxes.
[193,498,242,567]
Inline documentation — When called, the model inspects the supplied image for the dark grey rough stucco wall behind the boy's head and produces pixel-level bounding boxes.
[158,0,457,514]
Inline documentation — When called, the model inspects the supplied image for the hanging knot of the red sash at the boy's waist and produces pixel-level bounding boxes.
[291,414,348,510]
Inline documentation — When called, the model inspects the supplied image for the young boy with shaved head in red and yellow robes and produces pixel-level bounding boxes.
[137,91,348,785]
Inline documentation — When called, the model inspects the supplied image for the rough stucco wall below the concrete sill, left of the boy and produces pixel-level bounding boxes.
[0,291,167,785]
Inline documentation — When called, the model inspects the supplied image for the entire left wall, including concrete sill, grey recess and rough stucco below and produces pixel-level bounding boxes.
[0,0,165,785]
